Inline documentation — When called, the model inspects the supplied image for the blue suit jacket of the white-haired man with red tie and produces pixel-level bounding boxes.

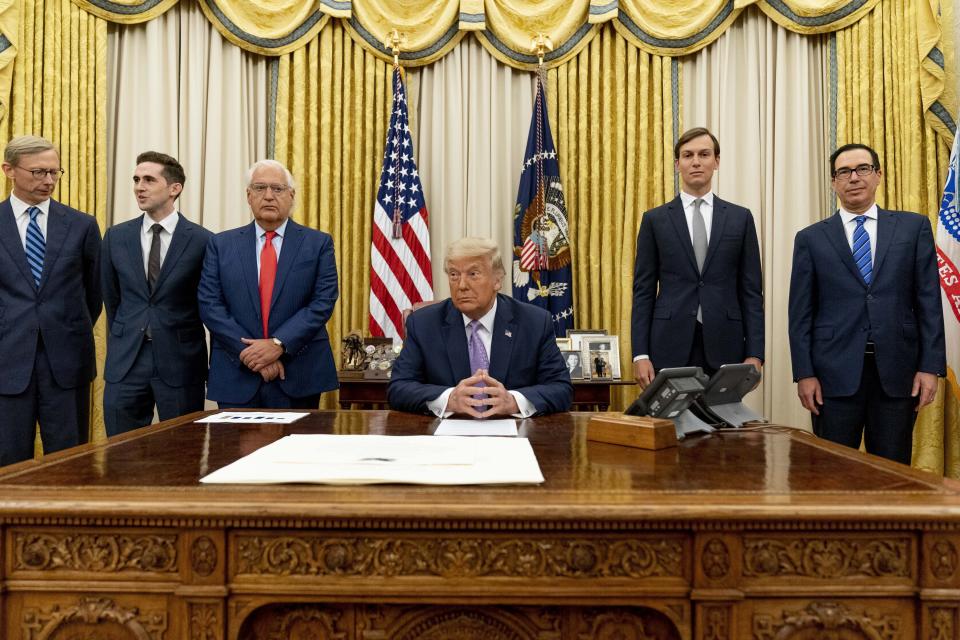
[199,220,339,403]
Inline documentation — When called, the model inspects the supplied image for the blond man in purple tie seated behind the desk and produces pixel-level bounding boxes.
[387,238,573,418]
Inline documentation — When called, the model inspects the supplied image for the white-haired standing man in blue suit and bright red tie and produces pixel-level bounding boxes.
[199,160,339,409]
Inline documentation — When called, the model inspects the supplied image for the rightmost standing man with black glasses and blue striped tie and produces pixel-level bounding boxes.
[789,144,946,464]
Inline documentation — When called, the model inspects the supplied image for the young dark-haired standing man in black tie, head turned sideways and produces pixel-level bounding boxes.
[100,151,213,436]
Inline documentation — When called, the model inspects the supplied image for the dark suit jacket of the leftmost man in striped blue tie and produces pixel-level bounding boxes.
[0,199,103,395]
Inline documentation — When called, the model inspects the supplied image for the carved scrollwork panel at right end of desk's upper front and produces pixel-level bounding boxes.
[743,537,911,579]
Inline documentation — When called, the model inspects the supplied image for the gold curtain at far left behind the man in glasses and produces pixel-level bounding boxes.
[0,0,107,438]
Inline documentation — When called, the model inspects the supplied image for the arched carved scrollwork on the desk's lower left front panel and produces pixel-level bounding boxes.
[21,598,167,640]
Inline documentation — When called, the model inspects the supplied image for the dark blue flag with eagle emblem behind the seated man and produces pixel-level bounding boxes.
[513,76,573,336]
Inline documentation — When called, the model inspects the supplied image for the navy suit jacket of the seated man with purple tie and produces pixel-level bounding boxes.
[387,294,573,414]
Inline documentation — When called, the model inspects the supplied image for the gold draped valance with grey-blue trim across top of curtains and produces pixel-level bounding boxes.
[63,0,879,62]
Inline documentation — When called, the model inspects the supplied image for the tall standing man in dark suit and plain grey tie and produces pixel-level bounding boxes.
[631,127,764,386]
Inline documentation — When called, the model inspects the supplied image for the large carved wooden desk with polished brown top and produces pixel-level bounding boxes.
[0,411,960,640]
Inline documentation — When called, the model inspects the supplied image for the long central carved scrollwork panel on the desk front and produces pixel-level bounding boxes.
[238,536,683,578]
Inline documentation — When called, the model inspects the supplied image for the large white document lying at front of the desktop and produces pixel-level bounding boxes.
[200,434,543,485]
